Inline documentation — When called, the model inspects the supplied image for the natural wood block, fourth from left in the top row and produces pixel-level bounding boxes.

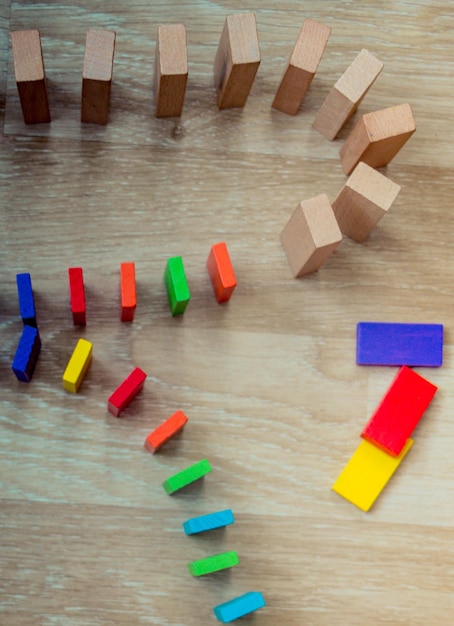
[214,13,260,109]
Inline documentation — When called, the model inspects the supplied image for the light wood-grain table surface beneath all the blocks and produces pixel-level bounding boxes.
[0,0,454,626]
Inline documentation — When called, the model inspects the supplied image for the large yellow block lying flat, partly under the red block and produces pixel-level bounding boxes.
[332,439,413,511]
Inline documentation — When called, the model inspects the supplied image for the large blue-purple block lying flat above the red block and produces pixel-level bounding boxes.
[356,322,443,367]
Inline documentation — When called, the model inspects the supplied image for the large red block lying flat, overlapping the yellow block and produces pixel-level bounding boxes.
[361,366,437,456]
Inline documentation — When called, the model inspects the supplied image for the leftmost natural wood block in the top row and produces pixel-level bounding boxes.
[11,29,50,124]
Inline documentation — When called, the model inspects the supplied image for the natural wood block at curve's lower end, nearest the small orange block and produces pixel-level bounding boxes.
[281,194,342,278]
